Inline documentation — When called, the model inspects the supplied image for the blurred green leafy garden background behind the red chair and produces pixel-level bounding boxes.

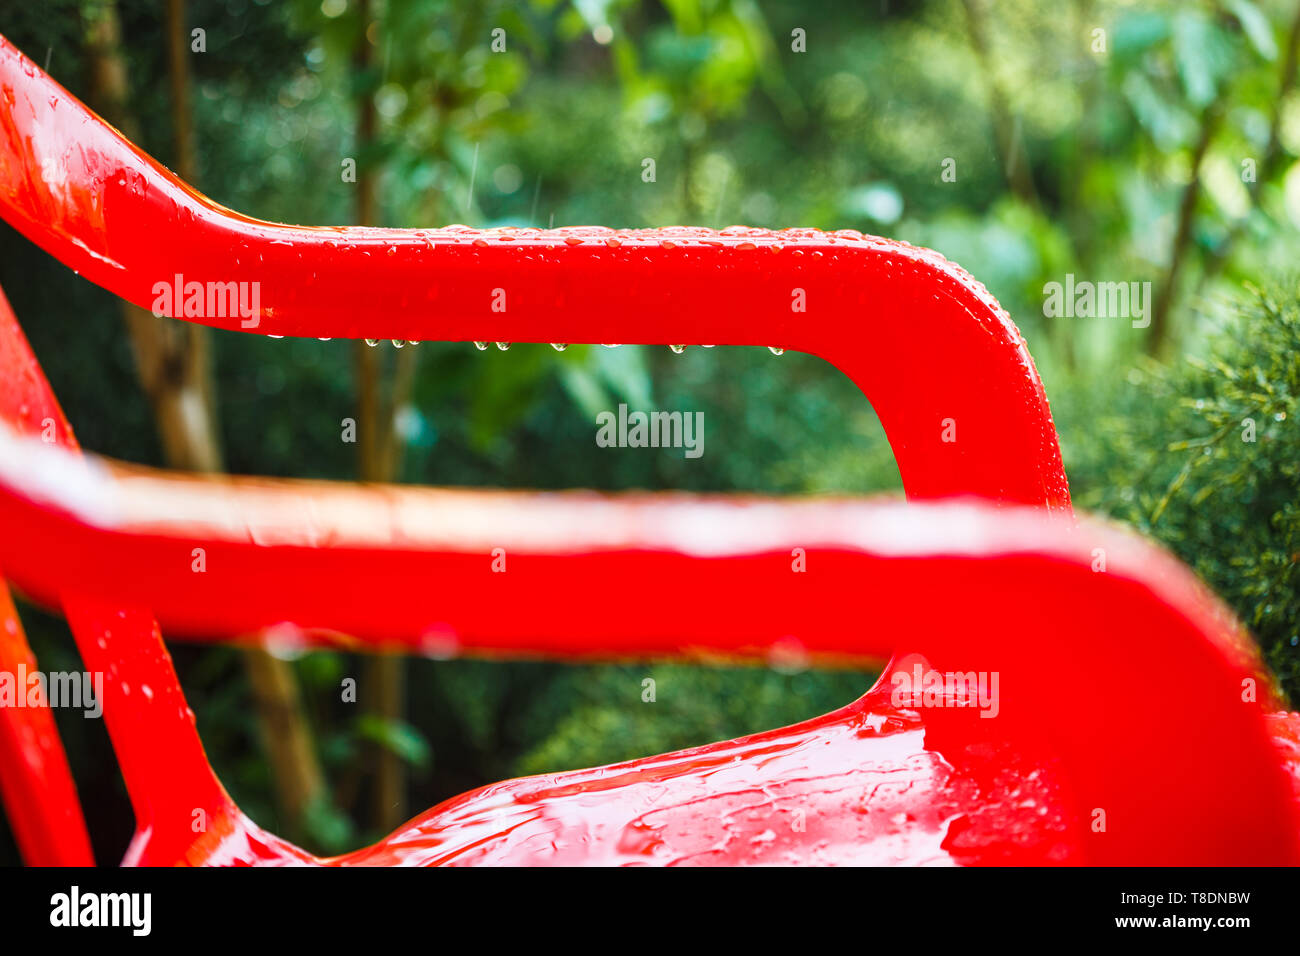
[0,0,1300,862]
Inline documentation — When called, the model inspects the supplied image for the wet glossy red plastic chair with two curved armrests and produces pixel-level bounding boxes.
[0,33,1297,864]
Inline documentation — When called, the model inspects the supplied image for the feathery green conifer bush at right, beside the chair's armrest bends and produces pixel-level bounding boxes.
[1053,282,1300,700]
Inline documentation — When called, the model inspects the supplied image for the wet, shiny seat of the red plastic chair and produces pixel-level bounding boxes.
[149,679,1300,866]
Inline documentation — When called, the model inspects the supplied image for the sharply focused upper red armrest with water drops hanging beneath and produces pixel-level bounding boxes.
[0,36,1070,509]
